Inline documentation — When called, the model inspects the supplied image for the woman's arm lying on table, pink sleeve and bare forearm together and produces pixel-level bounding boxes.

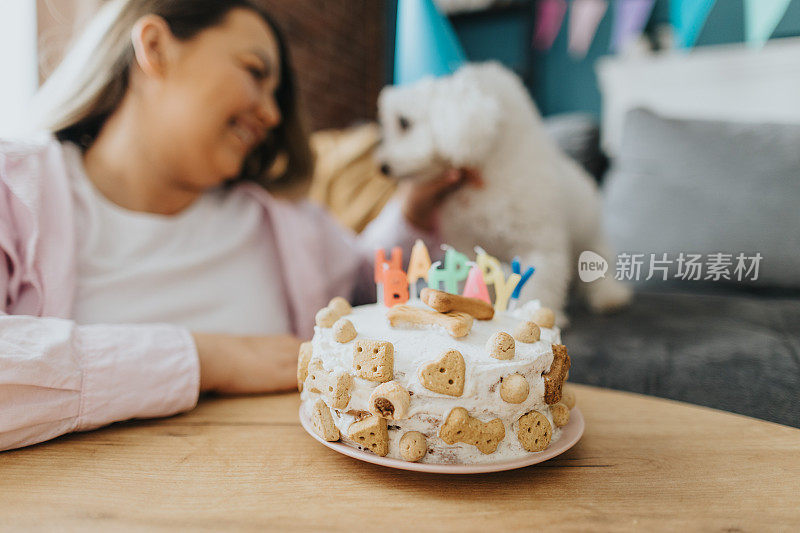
[0,315,300,450]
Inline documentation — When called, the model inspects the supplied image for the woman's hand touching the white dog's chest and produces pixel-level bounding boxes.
[398,168,483,231]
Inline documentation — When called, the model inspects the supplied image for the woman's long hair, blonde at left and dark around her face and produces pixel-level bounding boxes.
[34,0,313,196]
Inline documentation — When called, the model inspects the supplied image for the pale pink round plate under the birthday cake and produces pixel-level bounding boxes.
[300,406,584,474]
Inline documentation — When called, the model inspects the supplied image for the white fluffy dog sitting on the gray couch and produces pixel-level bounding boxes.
[377,62,631,324]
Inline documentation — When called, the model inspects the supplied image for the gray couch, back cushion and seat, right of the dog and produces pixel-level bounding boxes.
[555,111,800,427]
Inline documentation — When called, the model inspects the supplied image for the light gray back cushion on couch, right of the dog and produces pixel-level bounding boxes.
[605,110,800,287]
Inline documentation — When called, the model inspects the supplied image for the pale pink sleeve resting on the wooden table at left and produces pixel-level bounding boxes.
[0,314,200,450]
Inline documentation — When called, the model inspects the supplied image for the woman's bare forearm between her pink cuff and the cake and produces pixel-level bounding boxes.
[192,333,300,394]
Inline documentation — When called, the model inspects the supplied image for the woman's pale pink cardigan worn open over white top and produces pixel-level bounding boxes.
[0,137,435,450]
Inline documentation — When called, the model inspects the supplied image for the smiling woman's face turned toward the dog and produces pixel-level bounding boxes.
[147,9,281,189]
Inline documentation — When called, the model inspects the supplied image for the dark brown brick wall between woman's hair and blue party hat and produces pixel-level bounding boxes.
[261,0,386,130]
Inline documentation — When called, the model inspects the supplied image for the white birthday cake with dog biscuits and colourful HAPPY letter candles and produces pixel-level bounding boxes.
[297,243,575,464]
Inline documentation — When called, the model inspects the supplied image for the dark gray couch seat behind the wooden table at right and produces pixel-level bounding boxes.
[563,290,800,427]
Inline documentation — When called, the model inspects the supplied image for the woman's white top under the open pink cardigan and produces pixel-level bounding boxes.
[65,145,289,335]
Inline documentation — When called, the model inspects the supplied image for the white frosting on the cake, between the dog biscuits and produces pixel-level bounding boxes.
[302,300,561,463]
